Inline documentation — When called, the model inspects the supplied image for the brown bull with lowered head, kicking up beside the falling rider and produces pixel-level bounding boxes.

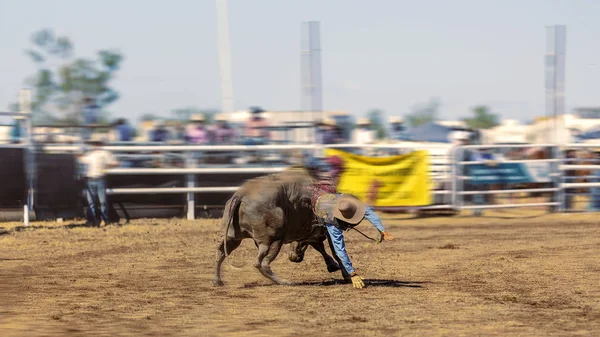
[213,170,339,285]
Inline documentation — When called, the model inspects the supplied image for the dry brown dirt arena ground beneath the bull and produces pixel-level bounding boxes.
[0,211,600,336]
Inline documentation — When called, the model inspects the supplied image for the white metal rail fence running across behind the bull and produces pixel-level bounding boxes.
[7,136,600,223]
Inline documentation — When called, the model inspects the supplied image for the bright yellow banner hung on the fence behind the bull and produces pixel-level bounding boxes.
[325,149,432,207]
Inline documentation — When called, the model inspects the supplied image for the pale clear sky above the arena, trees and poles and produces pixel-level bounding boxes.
[0,0,600,121]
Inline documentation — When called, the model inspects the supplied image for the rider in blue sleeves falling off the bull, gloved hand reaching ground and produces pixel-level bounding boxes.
[313,193,392,289]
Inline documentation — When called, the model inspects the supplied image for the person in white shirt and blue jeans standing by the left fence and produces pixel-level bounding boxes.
[79,138,118,227]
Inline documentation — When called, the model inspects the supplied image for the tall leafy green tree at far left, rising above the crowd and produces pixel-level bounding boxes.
[17,29,123,123]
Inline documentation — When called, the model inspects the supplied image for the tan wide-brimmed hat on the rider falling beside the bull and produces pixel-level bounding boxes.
[315,193,367,225]
